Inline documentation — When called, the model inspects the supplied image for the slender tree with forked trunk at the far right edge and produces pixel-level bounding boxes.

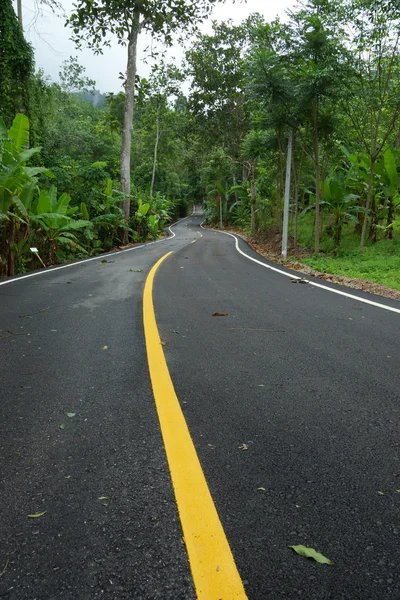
[344,0,400,250]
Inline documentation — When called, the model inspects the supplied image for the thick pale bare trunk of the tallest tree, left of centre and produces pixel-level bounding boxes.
[120,11,140,244]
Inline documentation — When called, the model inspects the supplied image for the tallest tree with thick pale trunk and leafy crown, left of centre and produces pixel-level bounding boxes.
[69,0,223,241]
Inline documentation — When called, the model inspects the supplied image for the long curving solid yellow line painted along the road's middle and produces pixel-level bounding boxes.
[143,252,247,600]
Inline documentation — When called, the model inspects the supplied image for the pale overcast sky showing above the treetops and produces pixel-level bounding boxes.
[15,0,295,93]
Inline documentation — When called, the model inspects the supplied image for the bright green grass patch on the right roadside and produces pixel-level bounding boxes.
[290,215,400,290]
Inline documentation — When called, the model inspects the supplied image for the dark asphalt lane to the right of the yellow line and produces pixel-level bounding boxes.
[155,220,400,600]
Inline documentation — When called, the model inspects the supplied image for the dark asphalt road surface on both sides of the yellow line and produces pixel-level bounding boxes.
[0,216,400,600]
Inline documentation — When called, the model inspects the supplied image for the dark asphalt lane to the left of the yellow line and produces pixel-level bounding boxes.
[0,222,196,600]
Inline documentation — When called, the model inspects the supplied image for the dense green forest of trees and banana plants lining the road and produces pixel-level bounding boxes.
[0,0,400,289]
